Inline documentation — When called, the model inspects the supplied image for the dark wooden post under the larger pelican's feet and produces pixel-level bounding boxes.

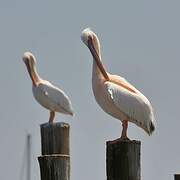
[106,140,141,180]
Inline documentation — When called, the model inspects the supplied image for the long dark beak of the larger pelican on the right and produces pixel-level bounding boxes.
[88,37,109,80]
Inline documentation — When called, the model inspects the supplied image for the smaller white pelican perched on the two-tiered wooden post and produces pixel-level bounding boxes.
[23,52,73,123]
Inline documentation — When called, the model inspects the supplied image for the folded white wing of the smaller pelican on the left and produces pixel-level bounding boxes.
[35,81,73,115]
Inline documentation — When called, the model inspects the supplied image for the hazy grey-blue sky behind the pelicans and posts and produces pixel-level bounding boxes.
[0,0,180,180]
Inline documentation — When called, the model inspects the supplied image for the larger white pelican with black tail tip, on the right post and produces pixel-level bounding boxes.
[81,28,155,140]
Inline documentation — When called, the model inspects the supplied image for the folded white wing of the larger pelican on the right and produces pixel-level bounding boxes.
[105,81,154,134]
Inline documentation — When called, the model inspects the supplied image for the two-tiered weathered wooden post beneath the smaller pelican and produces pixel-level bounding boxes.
[38,123,70,180]
